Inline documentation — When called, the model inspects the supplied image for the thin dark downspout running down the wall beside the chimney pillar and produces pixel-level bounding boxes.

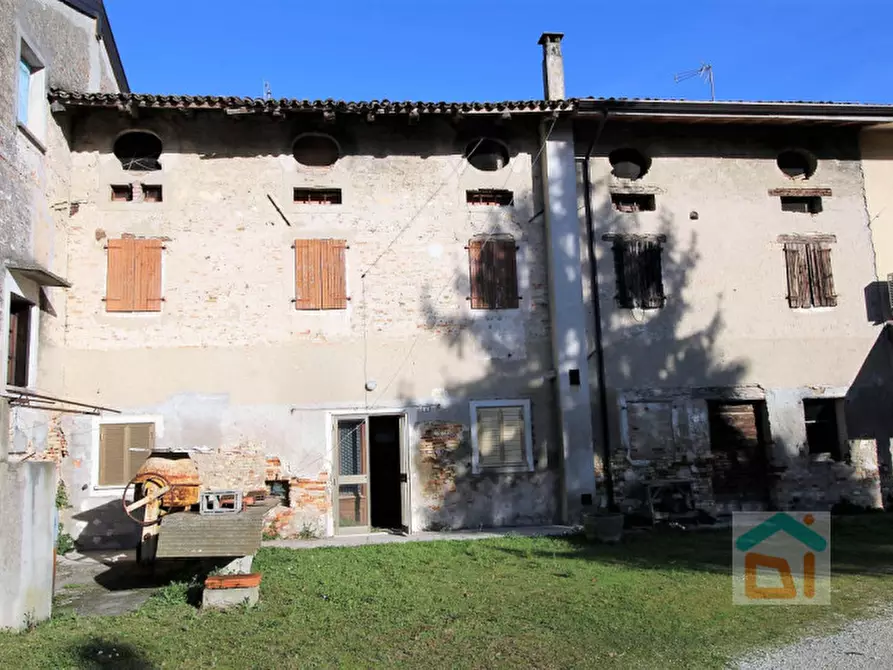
[583,110,615,510]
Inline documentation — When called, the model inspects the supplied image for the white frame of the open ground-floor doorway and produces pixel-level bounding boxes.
[326,407,415,535]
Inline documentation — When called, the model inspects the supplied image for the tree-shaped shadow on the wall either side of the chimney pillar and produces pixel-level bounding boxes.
[397,165,746,540]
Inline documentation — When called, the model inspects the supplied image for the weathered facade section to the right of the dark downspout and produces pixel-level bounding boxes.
[577,103,889,516]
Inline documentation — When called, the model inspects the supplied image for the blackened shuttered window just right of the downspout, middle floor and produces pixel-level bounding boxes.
[613,236,666,309]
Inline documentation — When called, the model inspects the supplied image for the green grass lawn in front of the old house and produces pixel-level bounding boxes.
[0,515,893,668]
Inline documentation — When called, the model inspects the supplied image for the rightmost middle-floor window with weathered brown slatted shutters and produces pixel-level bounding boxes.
[784,240,837,309]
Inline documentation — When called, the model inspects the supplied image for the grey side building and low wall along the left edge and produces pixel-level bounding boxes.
[0,0,127,628]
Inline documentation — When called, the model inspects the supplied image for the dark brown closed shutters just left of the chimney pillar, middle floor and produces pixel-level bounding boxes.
[468,235,518,309]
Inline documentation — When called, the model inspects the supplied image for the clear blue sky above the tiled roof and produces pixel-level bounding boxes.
[106,0,893,103]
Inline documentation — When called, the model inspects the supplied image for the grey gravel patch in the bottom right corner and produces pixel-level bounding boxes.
[738,608,893,670]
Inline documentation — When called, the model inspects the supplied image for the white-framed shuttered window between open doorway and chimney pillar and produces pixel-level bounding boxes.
[470,399,533,474]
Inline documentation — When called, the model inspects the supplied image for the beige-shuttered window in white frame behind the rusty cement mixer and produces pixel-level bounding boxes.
[92,415,162,495]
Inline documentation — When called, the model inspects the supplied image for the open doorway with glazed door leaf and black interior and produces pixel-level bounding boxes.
[335,414,409,533]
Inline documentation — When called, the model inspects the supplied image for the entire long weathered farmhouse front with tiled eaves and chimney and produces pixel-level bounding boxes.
[6,23,893,546]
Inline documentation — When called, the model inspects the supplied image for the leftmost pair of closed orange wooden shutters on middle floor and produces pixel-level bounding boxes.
[105,237,163,312]
